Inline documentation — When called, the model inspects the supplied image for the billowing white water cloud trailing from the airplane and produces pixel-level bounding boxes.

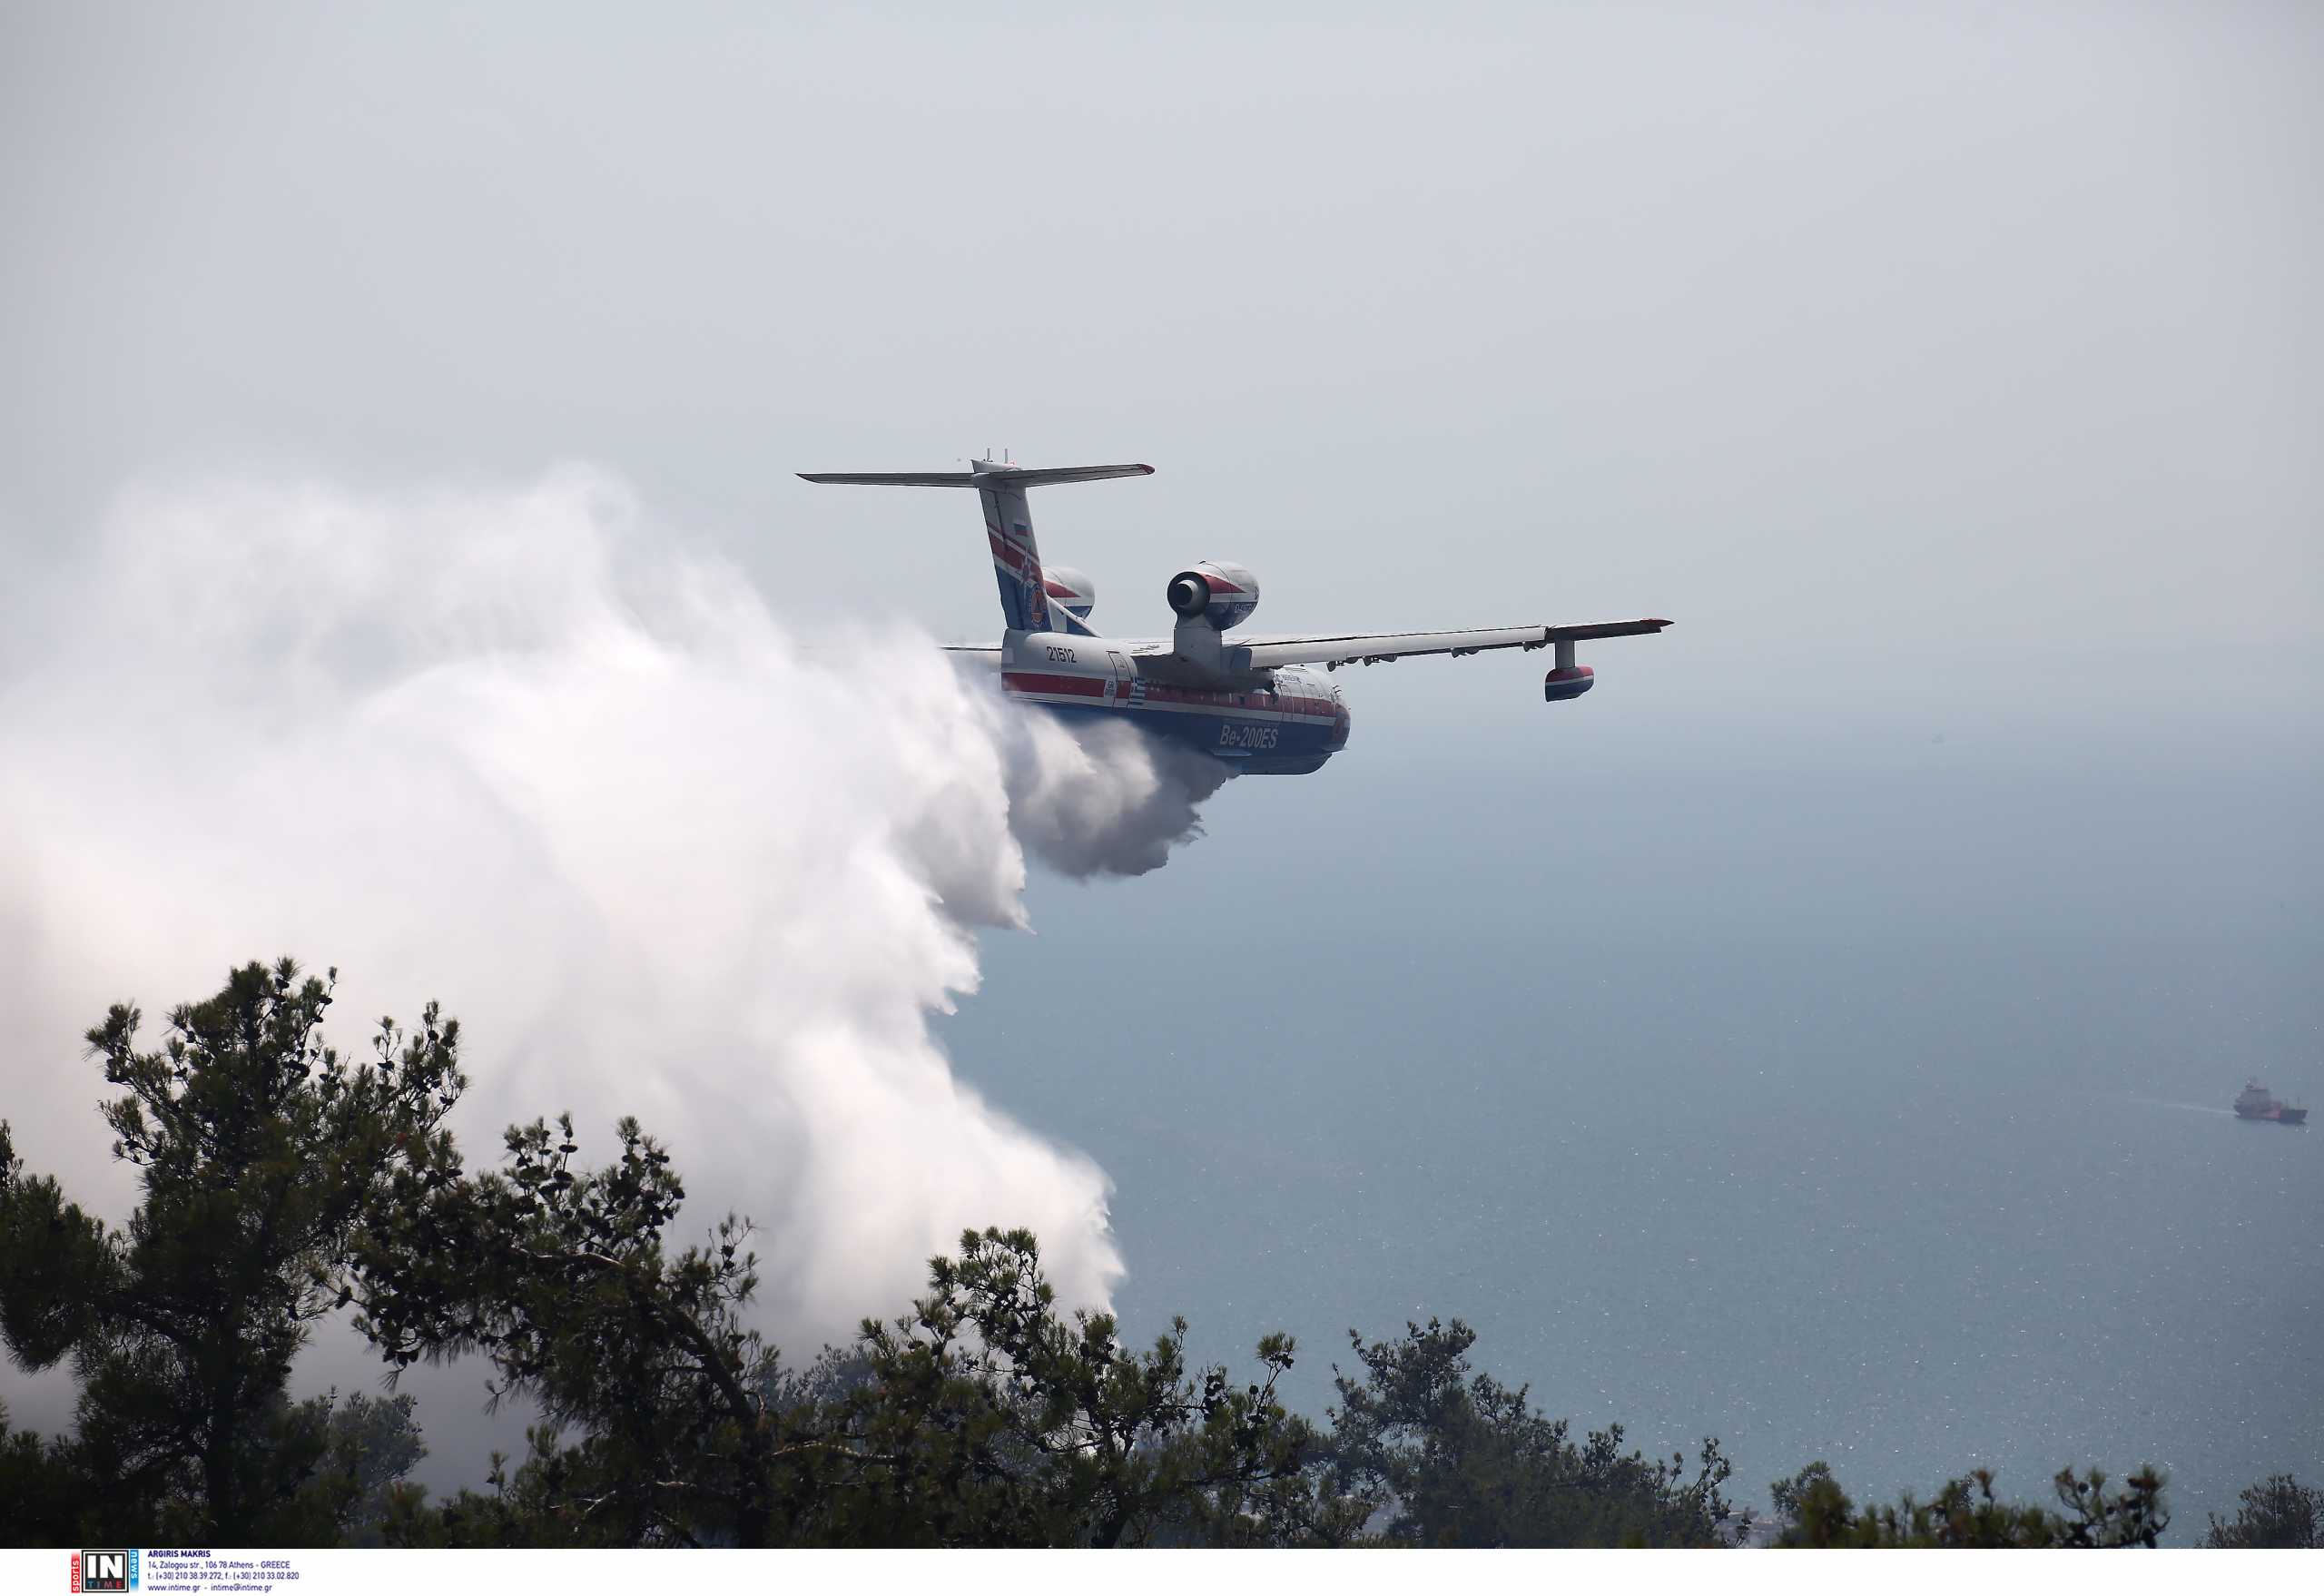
[0,469,1216,1350]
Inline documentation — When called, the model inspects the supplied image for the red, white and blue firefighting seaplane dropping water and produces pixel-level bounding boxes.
[800,460,1671,776]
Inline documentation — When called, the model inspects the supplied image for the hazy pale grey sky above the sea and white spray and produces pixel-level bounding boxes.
[0,5,2324,714]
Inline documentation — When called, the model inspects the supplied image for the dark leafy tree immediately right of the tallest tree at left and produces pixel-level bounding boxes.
[356,1118,781,1545]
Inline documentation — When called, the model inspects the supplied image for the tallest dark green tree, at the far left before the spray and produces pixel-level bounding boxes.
[0,960,462,1542]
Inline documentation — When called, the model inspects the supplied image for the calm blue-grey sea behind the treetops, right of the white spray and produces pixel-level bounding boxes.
[946,720,2324,1541]
